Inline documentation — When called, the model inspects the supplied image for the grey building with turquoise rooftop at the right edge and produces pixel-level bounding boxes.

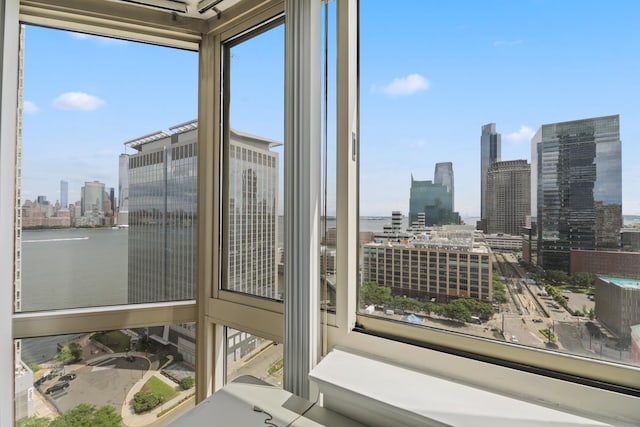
[595,276,640,339]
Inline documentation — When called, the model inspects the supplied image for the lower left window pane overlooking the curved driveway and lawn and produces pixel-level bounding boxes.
[14,324,195,426]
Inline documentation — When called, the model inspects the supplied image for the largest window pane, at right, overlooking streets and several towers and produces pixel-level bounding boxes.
[359,1,640,370]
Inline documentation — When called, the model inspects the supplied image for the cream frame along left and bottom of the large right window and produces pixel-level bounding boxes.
[326,0,640,422]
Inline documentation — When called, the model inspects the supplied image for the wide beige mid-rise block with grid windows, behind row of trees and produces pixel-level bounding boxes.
[362,230,493,302]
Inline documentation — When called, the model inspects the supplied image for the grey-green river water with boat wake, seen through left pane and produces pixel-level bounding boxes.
[21,228,128,311]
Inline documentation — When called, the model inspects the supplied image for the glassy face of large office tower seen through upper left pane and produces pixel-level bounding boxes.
[120,121,198,303]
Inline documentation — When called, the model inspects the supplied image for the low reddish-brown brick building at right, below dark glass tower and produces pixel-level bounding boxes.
[569,249,640,277]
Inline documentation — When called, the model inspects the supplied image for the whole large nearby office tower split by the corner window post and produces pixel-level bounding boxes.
[126,121,279,303]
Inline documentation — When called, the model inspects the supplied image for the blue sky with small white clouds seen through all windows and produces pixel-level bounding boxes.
[23,0,640,218]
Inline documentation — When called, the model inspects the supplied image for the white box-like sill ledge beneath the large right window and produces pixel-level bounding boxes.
[309,349,633,427]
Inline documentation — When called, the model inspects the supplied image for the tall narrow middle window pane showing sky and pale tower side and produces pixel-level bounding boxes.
[222,23,285,299]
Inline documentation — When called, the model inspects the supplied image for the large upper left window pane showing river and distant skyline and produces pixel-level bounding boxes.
[15,26,198,311]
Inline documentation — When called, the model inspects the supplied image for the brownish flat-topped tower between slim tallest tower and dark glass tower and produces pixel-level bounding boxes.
[486,160,531,235]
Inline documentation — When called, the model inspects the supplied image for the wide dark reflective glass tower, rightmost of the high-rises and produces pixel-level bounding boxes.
[537,115,622,271]
